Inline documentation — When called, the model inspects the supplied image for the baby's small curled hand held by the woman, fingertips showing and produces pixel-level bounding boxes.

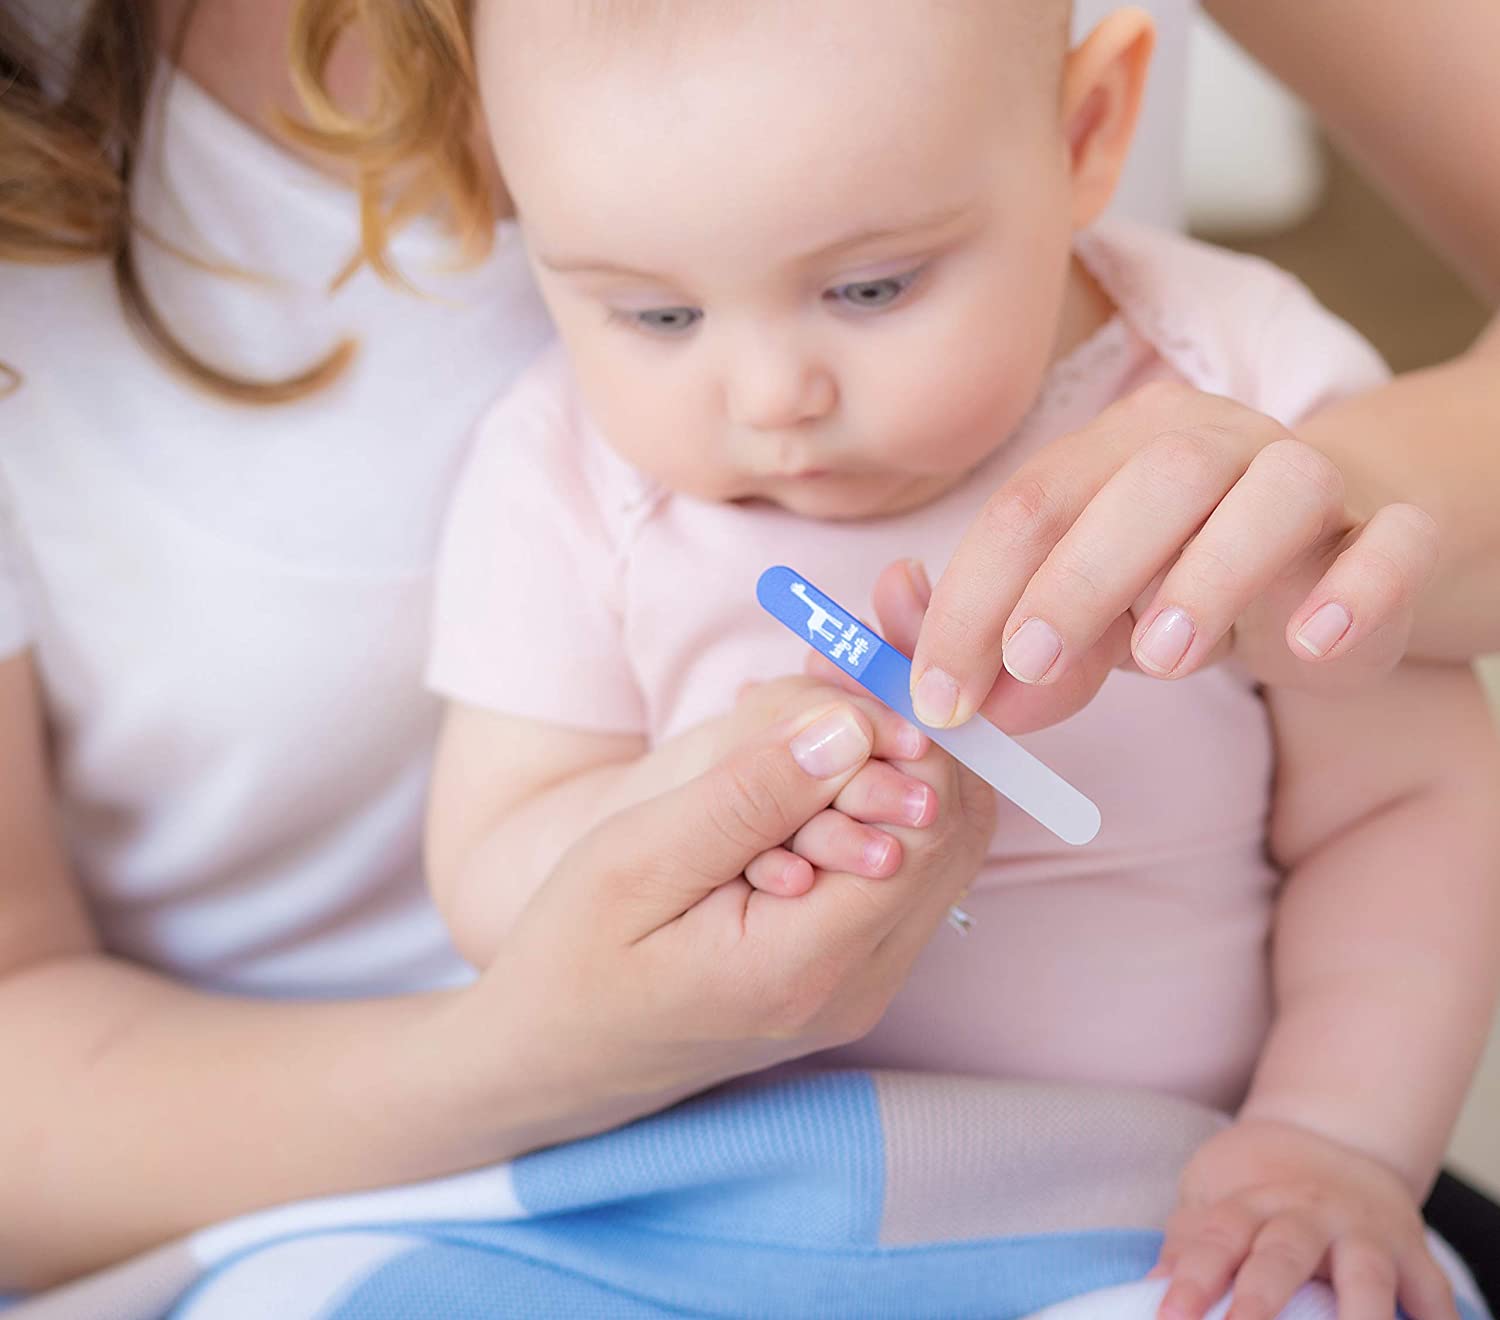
[723,677,938,897]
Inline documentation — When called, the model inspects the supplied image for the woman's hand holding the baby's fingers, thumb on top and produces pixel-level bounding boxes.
[455,701,995,1151]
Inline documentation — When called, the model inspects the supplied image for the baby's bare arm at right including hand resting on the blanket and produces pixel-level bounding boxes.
[1163,666,1500,1320]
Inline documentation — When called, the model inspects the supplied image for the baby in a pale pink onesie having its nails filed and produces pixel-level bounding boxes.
[429,0,1500,1317]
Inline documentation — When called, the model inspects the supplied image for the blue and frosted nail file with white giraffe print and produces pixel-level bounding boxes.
[756,566,1100,843]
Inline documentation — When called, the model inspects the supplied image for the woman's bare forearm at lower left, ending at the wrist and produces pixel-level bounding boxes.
[0,956,540,1293]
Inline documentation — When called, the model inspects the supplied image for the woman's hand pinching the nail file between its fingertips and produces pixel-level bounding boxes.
[888,384,1437,732]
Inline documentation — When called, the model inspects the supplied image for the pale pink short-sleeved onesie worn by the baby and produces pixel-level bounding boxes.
[429,225,1385,1109]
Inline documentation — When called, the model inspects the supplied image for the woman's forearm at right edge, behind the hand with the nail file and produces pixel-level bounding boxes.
[1298,321,1500,660]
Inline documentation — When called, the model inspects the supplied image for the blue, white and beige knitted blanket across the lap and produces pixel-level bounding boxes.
[6,1071,1487,1320]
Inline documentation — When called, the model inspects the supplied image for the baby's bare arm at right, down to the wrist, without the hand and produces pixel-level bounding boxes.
[1244,666,1500,1197]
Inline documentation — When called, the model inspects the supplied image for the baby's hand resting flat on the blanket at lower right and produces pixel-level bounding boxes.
[1152,1119,1458,1320]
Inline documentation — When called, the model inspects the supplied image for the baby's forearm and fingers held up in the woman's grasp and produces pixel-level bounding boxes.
[426,677,938,966]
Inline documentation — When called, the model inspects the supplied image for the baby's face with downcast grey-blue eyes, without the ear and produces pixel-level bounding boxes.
[476,0,1073,519]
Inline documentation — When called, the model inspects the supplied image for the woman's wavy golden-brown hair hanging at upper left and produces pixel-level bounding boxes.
[0,0,495,404]
